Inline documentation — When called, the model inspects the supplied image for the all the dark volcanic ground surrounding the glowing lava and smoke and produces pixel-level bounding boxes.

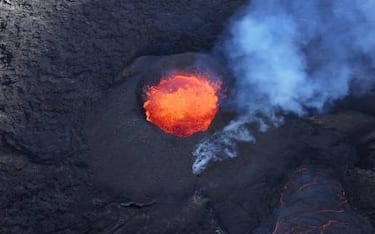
[0,0,375,233]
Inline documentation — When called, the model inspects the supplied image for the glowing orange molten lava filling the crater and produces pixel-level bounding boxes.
[143,74,221,137]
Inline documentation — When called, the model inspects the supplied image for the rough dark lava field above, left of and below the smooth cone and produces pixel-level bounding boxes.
[0,0,247,234]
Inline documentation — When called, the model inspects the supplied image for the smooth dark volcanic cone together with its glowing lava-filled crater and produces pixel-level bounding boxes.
[86,53,228,200]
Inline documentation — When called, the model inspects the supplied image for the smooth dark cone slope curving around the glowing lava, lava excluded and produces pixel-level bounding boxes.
[85,53,229,199]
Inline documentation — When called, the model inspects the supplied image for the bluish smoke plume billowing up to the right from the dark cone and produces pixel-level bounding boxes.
[193,0,375,173]
